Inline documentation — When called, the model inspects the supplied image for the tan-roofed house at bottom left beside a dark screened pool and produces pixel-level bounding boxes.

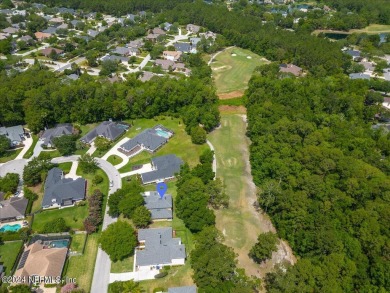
[14,241,68,285]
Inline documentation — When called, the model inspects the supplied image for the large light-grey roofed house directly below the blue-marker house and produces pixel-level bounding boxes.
[134,227,186,271]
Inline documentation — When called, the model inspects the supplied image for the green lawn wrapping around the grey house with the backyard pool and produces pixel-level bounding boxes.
[119,117,208,173]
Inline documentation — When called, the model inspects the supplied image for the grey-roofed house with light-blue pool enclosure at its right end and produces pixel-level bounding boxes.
[119,125,173,156]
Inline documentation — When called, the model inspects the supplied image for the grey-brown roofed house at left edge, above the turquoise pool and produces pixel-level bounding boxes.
[0,192,28,223]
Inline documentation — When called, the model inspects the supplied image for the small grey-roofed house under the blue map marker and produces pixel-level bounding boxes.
[142,191,172,221]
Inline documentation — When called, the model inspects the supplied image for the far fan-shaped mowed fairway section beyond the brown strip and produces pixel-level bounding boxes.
[210,47,266,94]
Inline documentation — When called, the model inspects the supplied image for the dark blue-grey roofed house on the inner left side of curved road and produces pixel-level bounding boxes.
[42,168,87,209]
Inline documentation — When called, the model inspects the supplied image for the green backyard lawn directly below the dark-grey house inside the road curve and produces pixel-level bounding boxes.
[32,205,88,232]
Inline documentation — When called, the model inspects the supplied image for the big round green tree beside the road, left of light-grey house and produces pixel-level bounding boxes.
[99,221,137,262]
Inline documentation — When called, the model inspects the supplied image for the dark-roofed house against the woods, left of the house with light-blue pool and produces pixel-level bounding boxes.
[80,121,129,144]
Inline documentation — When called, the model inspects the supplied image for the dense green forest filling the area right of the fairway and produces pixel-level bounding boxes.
[246,65,390,292]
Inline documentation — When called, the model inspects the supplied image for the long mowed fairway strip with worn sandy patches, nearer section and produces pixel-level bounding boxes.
[208,113,270,276]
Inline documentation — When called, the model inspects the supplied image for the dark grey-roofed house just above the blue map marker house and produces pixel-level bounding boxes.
[141,155,183,184]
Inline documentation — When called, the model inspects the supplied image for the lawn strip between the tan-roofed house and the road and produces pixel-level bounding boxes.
[64,234,99,292]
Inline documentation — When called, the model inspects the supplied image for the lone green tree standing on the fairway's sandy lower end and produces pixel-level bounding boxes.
[249,232,278,263]
